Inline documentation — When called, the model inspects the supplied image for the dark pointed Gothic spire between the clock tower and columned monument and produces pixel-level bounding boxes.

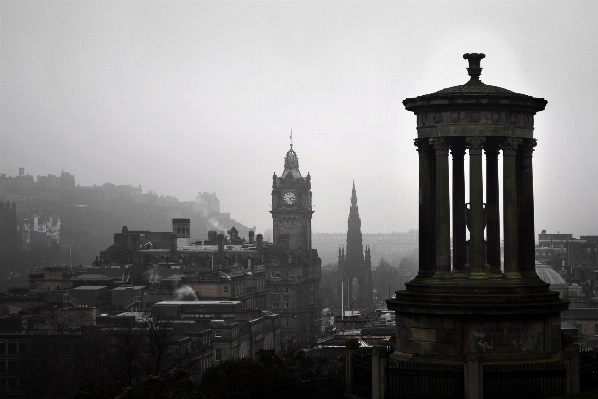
[338,182,372,310]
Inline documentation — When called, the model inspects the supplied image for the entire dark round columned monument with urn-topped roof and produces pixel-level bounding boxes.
[387,53,575,398]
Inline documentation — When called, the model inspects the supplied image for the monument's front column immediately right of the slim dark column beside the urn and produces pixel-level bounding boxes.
[501,139,521,278]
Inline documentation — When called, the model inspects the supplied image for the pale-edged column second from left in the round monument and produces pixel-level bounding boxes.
[430,138,453,278]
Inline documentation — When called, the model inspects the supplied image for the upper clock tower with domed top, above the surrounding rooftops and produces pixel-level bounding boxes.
[270,144,313,251]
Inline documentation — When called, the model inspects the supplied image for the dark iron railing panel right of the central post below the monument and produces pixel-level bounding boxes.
[483,362,567,399]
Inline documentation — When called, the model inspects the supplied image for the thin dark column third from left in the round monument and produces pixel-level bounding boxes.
[451,138,467,273]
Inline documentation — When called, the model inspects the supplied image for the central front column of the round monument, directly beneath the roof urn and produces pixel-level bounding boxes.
[465,137,488,279]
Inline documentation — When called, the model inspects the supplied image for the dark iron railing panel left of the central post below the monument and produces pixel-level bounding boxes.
[385,360,465,399]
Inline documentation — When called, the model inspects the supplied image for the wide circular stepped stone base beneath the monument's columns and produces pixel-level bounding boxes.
[387,277,569,398]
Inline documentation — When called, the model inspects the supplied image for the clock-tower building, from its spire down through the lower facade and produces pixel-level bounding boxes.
[265,144,322,344]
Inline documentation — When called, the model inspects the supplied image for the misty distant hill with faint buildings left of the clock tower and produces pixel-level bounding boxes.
[0,169,255,273]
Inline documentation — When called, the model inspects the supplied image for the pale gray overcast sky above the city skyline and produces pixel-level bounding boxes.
[0,0,598,236]
